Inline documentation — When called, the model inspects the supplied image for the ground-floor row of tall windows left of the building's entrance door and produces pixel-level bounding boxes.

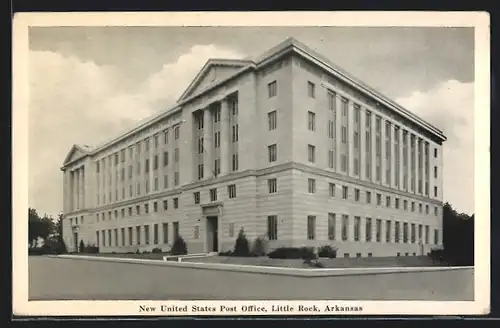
[96,222,180,247]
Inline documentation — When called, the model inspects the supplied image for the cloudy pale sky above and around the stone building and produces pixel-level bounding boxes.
[28,27,474,217]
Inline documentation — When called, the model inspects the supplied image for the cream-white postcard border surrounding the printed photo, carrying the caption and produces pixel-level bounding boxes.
[12,12,490,316]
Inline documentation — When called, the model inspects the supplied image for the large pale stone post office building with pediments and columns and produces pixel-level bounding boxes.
[62,39,446,257]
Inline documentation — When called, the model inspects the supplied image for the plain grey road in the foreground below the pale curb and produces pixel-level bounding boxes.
[29,256,474,301]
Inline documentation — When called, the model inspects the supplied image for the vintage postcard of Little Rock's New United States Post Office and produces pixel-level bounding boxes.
[12,12,490,316]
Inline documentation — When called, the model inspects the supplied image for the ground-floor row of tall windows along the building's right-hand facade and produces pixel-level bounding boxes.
[267,213,439,245]
